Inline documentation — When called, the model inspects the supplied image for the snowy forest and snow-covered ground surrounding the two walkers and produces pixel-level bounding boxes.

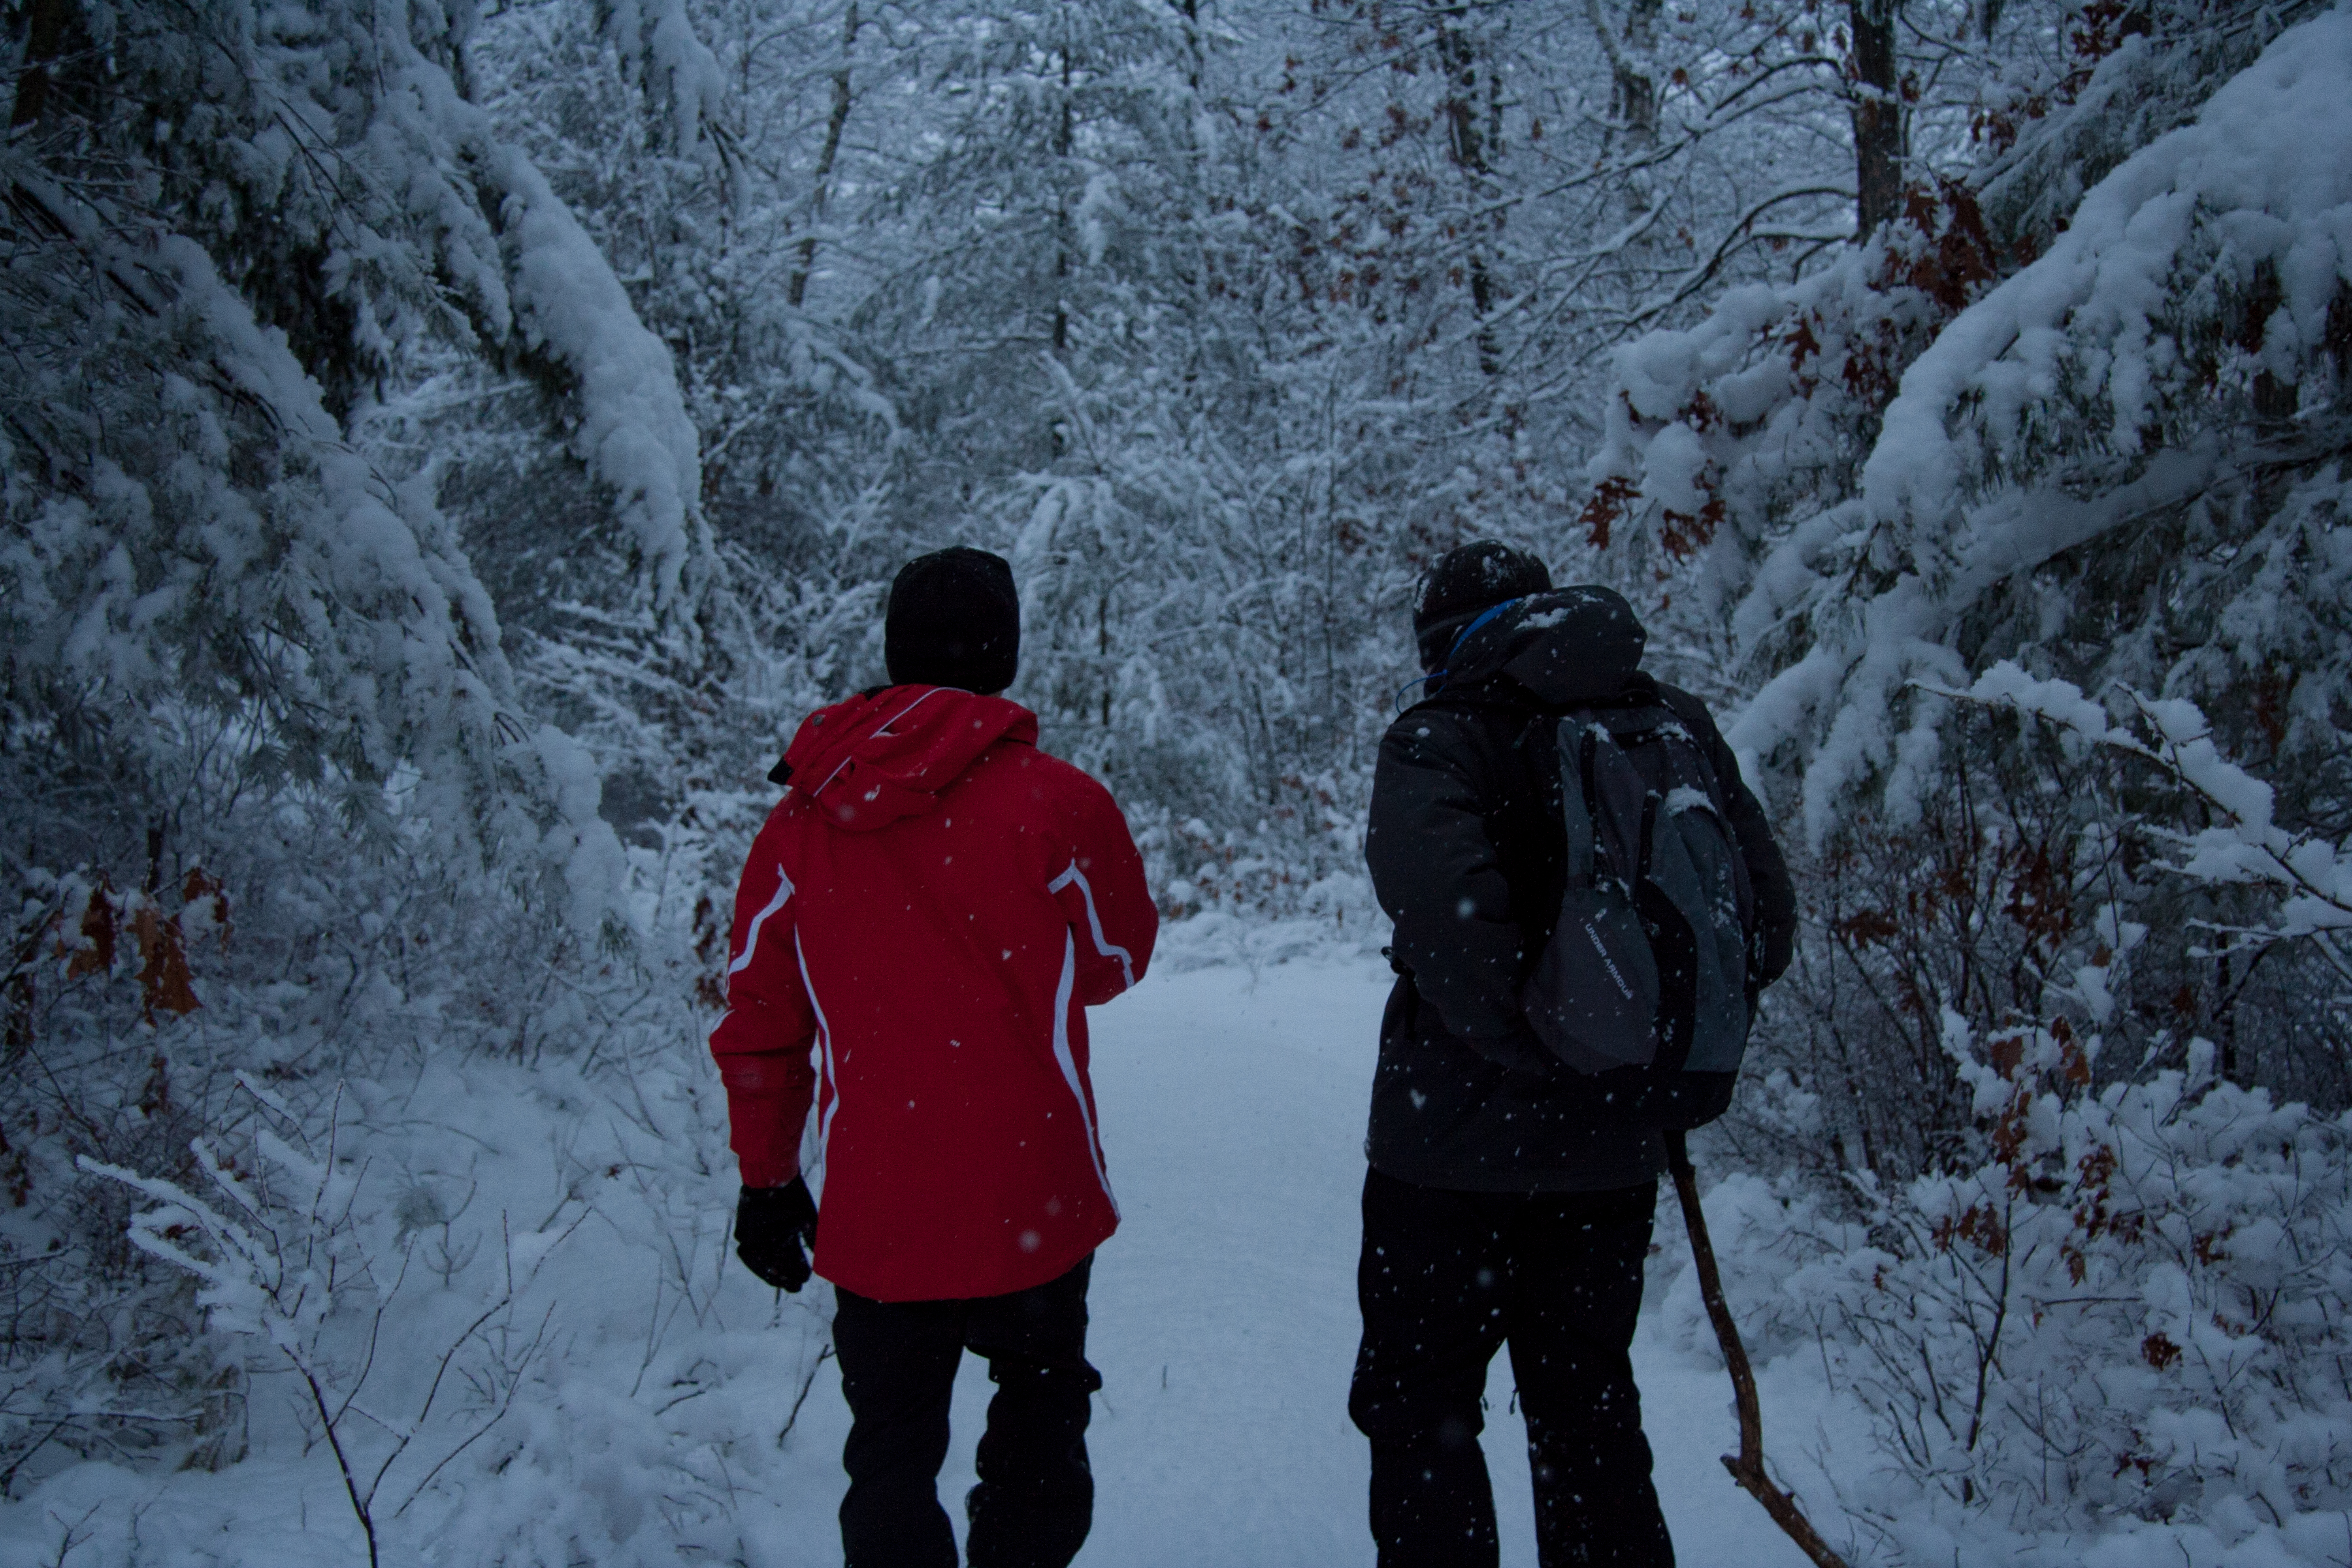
[0,0,2352,1568]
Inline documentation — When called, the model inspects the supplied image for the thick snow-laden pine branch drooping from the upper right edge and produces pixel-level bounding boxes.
[1733,12,2352,837]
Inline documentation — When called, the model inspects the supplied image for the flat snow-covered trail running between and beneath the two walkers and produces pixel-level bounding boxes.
[779,962,1804,1568]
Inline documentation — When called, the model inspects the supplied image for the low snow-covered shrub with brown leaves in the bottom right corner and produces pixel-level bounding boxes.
[1785,1034,2352,1563]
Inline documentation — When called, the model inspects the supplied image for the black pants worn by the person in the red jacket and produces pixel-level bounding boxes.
[832,1256,1103,1568]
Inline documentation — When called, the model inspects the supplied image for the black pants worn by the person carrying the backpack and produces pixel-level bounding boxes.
[1348,1171,1675,1568]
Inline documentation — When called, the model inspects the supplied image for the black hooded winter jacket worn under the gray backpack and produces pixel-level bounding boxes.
[1364,588,1797,1192]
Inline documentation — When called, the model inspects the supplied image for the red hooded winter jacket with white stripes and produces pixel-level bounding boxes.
[710,687,1160,1300]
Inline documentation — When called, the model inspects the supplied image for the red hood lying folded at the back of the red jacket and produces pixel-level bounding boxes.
[776,687,1037,832]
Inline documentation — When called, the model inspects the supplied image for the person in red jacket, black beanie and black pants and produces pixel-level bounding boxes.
[710,548,1160,1568]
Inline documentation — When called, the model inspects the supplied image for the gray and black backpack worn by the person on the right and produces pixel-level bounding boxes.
[1520,703,1754,1128]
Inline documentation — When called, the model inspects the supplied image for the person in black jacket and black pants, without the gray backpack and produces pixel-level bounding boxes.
[1348,543,1797,1568]
